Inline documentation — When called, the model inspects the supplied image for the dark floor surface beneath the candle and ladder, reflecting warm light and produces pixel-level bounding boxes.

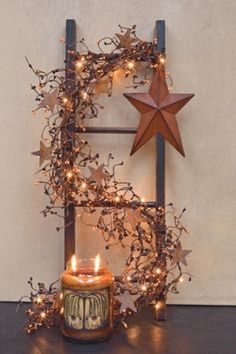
[0,303,236,354]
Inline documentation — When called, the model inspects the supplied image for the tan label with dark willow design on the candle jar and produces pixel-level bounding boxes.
[63,288,109,330]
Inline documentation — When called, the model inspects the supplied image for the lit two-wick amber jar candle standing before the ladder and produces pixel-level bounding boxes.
[61,256,113,342]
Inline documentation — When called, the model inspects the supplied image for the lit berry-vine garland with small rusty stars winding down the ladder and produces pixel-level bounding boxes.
[20,26,191,333]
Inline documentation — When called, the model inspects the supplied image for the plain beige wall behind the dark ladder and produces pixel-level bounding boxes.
[0,0,236,305]
